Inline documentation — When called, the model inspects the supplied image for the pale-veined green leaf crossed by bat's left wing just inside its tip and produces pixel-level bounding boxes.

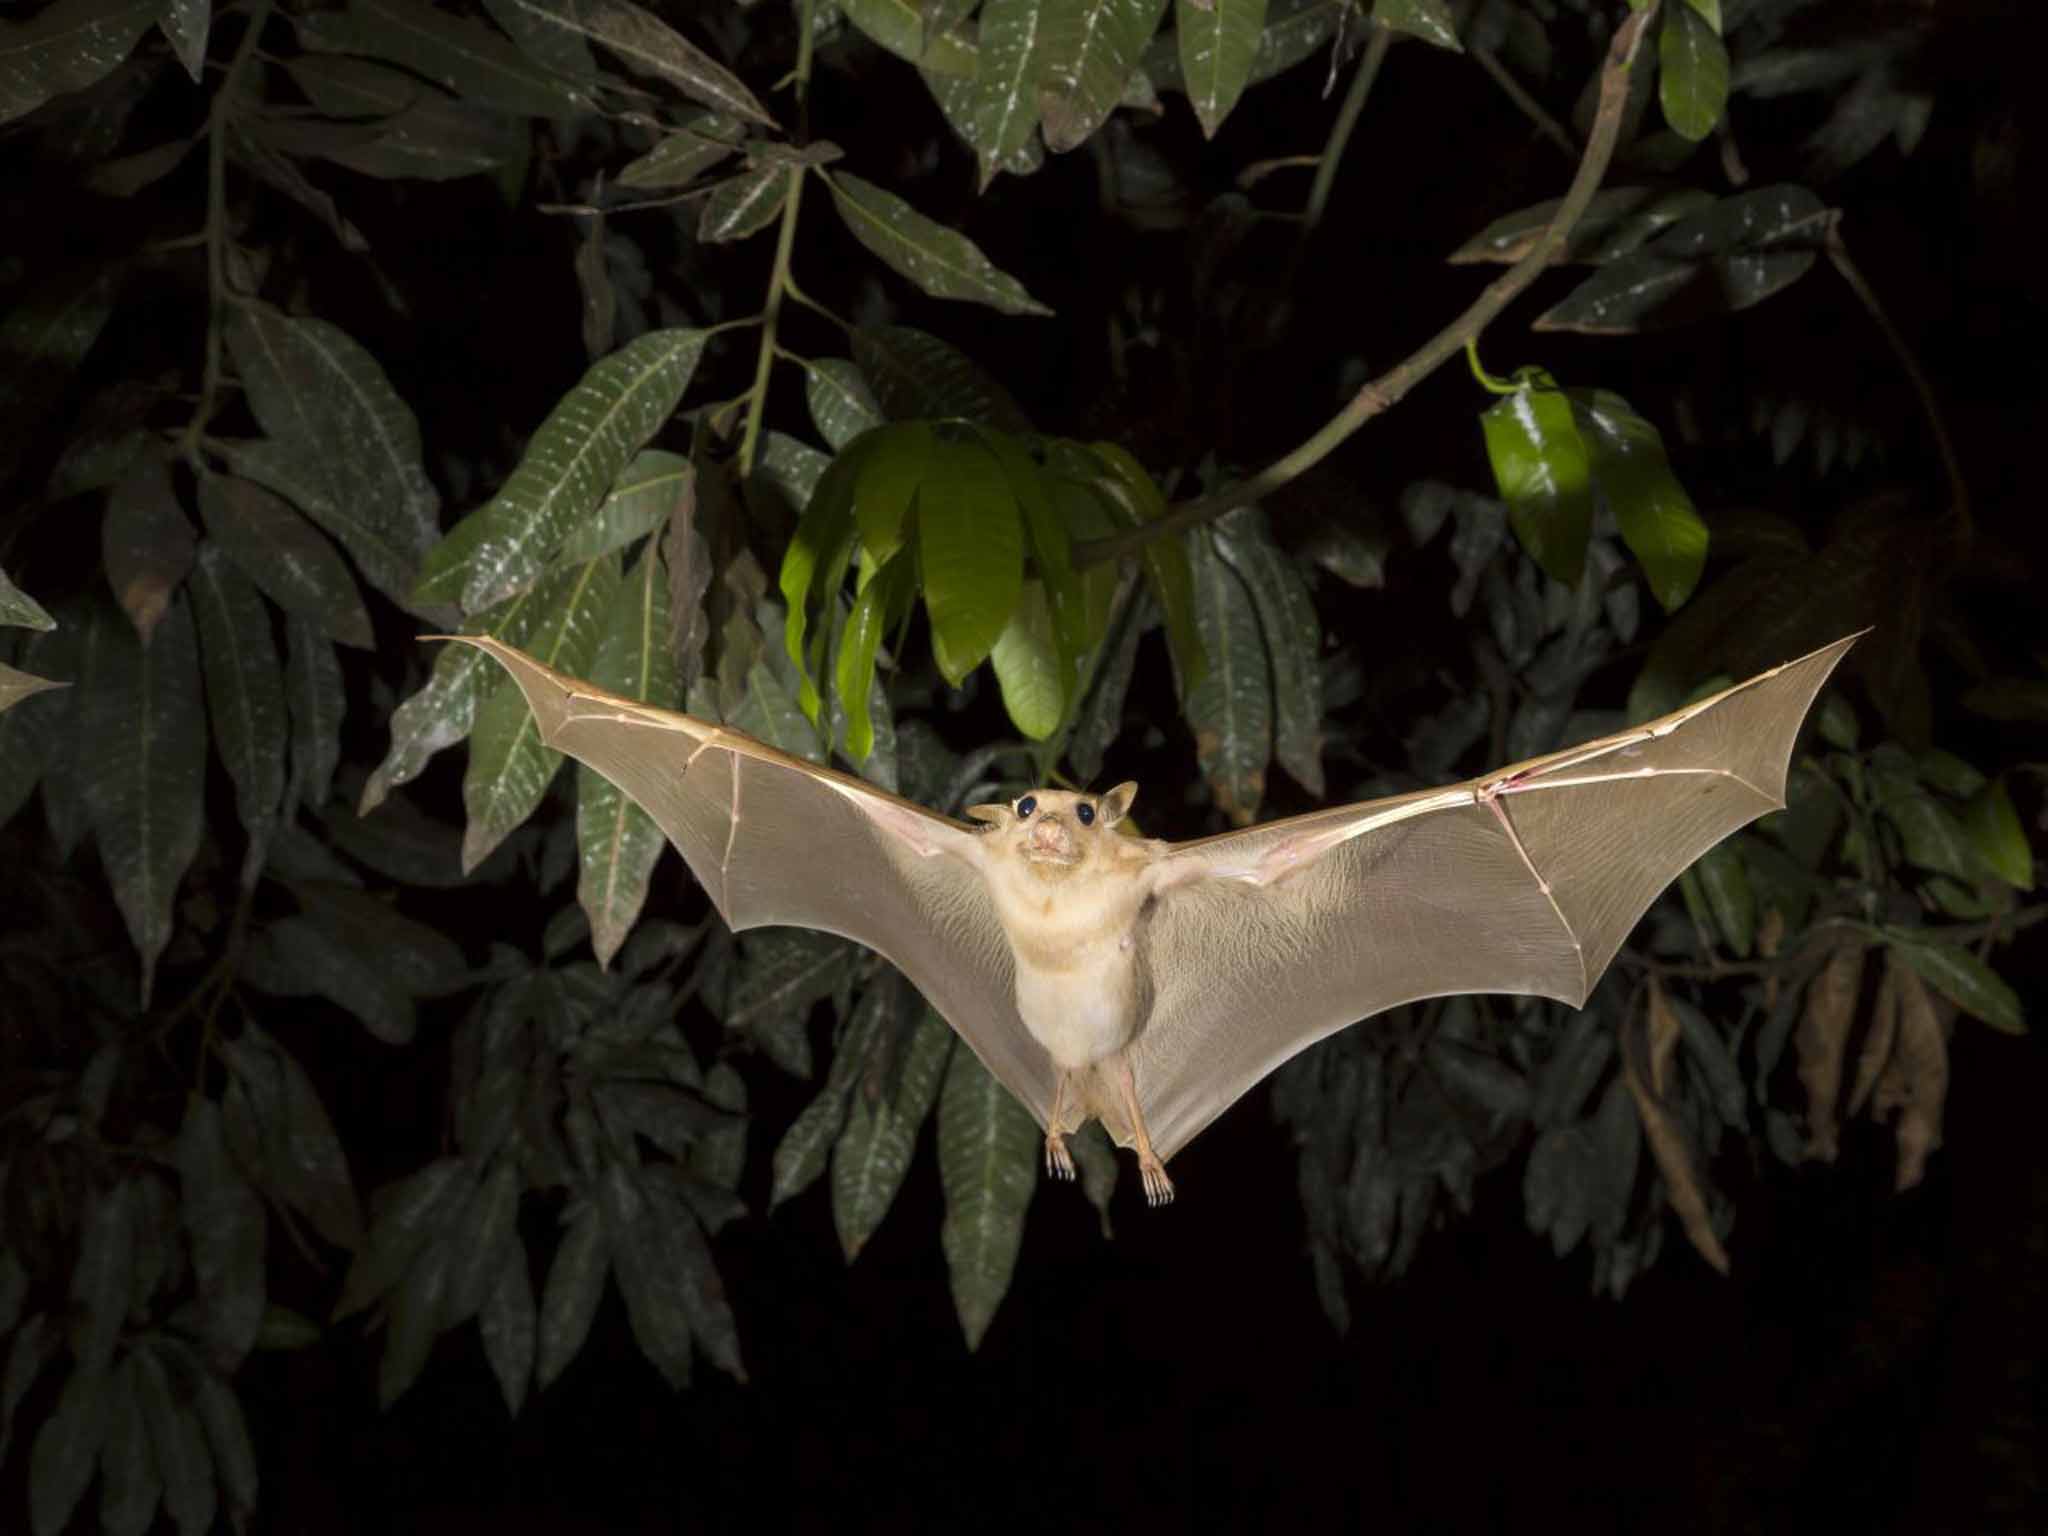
[463,555,614,874]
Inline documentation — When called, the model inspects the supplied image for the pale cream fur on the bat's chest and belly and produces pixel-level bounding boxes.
[978,881,1149,1069]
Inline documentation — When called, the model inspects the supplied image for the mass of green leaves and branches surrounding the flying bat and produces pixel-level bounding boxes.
[0,0,2048,1532]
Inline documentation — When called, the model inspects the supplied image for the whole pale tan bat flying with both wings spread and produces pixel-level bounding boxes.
[453,635,1858,1204]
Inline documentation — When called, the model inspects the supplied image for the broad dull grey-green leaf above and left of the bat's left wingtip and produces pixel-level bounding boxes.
[227,303,440,606]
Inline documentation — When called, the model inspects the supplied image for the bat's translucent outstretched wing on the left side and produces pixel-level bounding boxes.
[440,635,1053,1122]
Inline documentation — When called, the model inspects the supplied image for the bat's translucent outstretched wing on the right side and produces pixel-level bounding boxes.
[1112,635,1855,1157]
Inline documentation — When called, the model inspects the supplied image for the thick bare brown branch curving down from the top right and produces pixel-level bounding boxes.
[1073,0,1657,569]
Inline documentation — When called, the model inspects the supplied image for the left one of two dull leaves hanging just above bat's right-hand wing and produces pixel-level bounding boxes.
[1186,535,1274,827]
